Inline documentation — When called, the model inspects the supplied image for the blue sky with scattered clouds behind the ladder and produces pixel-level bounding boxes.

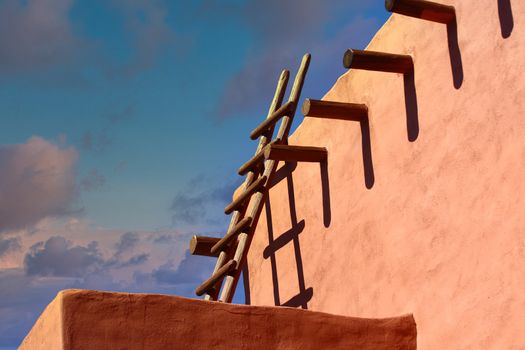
[0,0,388,349]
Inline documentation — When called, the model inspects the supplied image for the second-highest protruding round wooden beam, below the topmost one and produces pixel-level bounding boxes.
[343,49,414,74]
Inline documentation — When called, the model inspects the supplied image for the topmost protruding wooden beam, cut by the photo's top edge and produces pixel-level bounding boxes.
[385,0,456,24]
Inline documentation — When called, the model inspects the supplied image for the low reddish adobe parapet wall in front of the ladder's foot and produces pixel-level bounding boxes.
[20,290,416,350]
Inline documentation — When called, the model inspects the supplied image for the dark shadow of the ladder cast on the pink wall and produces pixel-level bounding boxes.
[263,166,316,309]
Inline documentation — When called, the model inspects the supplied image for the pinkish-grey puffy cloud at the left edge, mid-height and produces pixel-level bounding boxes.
[0,137,78,232]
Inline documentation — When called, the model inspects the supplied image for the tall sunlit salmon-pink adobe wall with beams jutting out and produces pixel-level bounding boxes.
[249,0,525,349]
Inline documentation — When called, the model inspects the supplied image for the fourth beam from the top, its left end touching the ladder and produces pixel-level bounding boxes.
[264,144,328,162]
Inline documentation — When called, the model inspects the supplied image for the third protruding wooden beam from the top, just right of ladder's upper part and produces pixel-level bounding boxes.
[302,98,368,121]
